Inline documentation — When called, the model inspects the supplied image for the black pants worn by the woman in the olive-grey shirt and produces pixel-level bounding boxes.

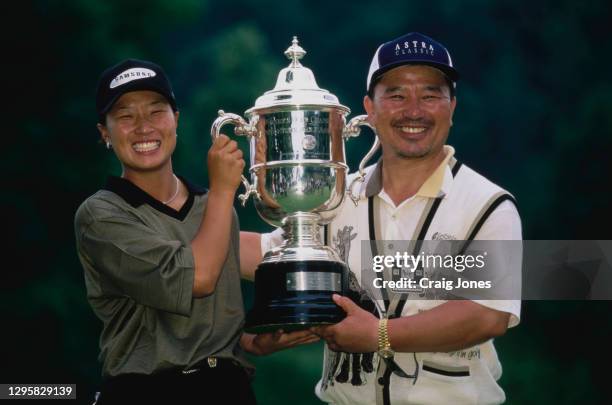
[96,359,257,405]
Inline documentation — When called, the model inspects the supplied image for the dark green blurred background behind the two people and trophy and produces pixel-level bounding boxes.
[0,0,612,405]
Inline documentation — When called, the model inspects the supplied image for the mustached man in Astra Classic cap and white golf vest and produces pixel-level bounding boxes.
[242,33,522,404]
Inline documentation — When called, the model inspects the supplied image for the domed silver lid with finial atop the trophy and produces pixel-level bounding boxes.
[246,36,350,115]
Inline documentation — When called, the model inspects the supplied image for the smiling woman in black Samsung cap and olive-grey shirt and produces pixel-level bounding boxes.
[75,59,314,404]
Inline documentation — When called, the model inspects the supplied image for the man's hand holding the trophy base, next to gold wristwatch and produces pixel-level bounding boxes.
[310,294,378,353]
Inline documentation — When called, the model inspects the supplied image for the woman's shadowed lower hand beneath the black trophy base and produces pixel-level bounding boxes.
[240,329,319,356]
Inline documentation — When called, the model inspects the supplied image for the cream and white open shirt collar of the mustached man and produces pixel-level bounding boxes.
[365,145,456,198]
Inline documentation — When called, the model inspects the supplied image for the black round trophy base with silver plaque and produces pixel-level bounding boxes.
[244,260,348,334]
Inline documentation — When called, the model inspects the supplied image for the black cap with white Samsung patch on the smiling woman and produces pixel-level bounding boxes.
[96,59,178,123]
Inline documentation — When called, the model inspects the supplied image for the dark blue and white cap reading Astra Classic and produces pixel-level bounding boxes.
[366,32,459,92]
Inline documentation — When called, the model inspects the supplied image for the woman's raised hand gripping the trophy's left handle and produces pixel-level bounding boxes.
[208,134,245,195]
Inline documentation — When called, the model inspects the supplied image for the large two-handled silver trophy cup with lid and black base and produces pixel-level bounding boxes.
[211,37,374,333]
